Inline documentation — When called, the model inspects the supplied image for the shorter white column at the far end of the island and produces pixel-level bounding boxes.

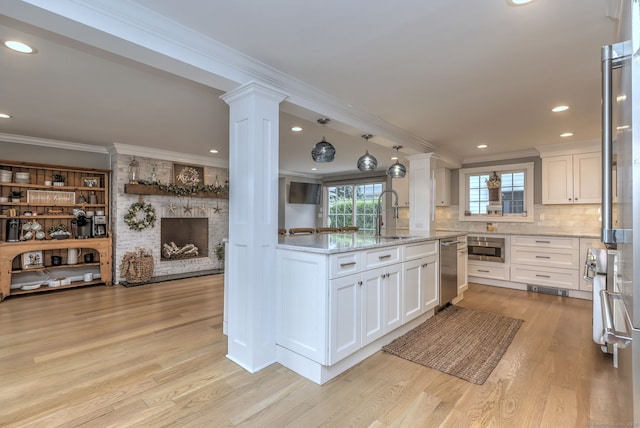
[407,153,438,233]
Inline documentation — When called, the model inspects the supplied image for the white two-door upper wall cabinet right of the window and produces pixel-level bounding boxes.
[542,152,602,204]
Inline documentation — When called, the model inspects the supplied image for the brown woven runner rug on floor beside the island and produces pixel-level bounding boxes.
[382,305,524,385]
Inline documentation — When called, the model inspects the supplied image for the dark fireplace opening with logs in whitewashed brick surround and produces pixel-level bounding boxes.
[160,217,209,261]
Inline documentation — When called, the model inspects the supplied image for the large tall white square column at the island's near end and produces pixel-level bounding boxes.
[220,82,286,373]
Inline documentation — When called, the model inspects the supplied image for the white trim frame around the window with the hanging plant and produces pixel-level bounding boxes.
[458,162,535,223]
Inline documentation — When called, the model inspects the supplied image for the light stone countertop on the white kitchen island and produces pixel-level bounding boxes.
[276,231,467,254]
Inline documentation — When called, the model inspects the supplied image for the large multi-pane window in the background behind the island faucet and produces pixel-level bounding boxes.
[327,183,383,231]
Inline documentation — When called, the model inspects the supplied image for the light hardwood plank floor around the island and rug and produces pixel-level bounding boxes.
[0,275,621,428]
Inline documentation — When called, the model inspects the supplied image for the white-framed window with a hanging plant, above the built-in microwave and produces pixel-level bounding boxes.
[460,162,533,222]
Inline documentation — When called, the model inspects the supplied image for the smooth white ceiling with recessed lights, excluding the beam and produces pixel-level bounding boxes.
[0,0,617,175]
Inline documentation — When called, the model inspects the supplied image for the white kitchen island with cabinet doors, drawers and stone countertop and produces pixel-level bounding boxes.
[276,232,464,384]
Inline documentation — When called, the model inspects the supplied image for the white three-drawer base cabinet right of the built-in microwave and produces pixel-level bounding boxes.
[511,235,580,290]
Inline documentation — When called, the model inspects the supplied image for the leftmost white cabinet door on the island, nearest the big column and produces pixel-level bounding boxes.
[329,274,363,365]
